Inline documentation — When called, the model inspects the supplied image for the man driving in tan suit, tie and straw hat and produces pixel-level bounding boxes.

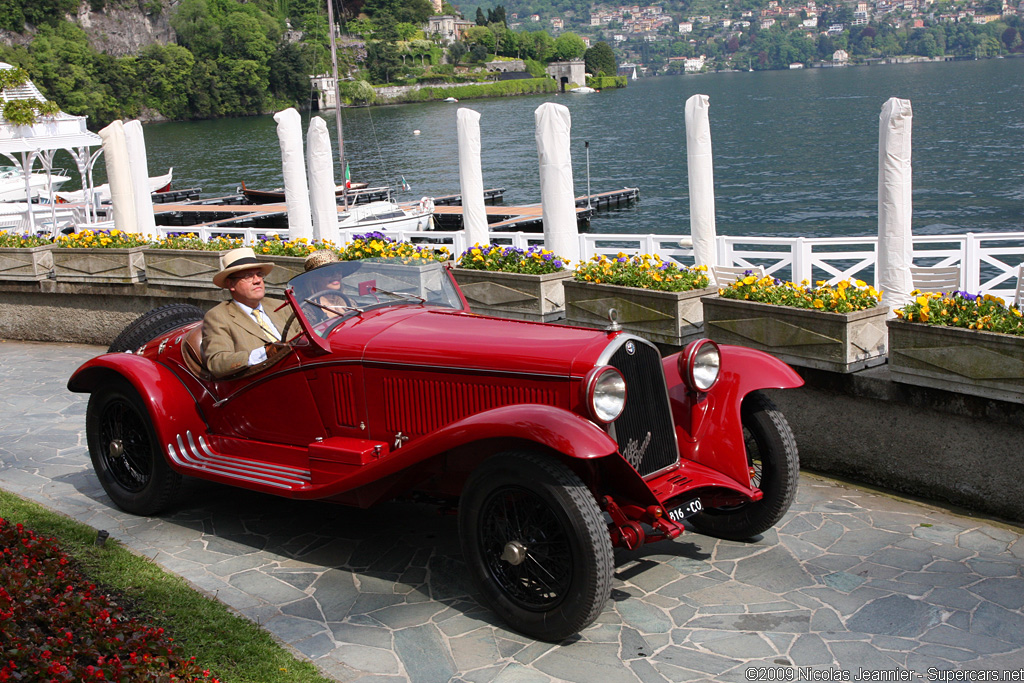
[202,247,290,378]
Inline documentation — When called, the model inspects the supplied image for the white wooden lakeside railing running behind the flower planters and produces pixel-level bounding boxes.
[99,220,1024,300]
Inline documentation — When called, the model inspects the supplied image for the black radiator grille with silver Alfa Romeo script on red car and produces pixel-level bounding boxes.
[608,338,679,476]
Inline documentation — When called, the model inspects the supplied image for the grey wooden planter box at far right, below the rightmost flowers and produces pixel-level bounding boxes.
[889,319,1024,403]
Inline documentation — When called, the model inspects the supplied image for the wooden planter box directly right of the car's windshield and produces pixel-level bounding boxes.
[452,268,572,323]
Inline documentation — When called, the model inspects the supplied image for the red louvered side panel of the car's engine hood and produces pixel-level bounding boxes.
[384,377,558,435]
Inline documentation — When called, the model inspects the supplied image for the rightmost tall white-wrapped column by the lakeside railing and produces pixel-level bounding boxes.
[876,97,913,317]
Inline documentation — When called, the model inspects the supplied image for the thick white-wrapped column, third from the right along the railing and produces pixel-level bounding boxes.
[534,102,580,265]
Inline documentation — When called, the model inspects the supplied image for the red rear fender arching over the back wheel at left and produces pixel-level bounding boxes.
[68,353,207,472]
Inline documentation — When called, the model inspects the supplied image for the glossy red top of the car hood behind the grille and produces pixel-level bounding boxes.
[356,308,609,377]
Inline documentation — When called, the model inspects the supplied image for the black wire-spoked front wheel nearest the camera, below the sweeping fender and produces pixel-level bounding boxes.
[459,453,612,642]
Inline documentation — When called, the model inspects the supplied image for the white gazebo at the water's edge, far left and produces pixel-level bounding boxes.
[0,61,102,235]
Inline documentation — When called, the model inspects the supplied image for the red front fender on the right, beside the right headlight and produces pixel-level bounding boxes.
[663,344,804,488]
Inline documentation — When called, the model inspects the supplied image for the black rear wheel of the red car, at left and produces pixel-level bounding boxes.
[85,379,181,515]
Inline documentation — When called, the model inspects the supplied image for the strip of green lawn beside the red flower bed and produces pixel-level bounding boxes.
[0,490,330,683]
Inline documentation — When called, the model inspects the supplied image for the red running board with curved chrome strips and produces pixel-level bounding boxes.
[167,430,312,490]
